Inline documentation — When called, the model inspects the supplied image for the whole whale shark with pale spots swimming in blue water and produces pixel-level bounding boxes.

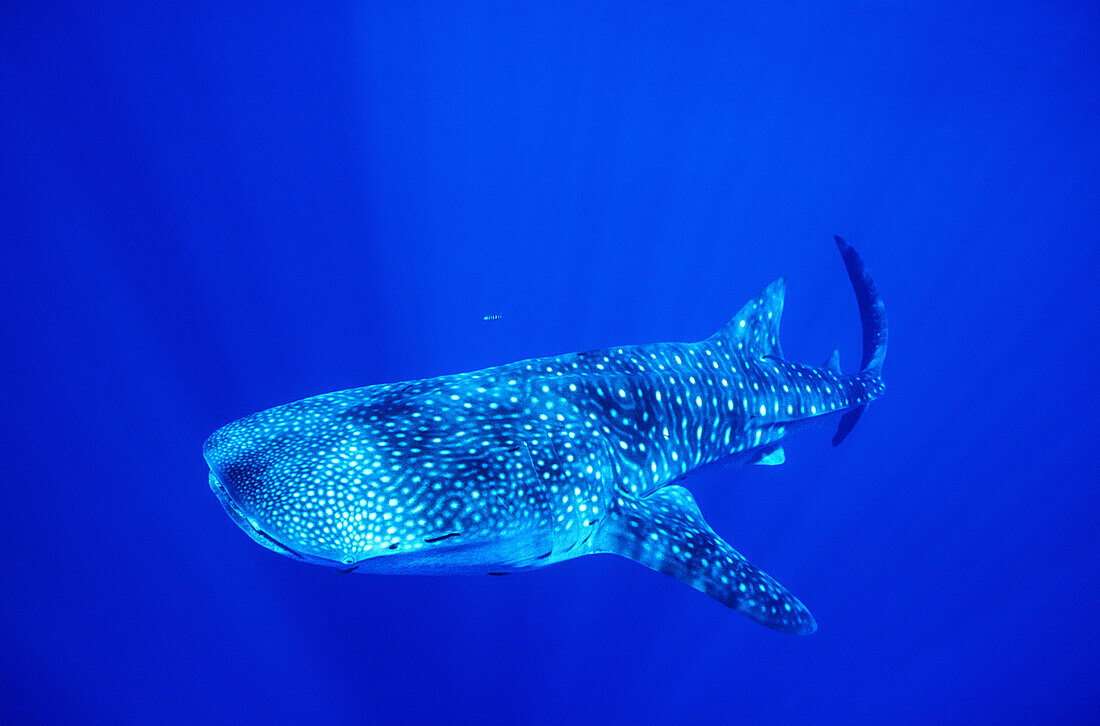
[202,238,887,634]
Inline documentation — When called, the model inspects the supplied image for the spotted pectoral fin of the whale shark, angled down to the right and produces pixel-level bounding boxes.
[596,486,817,635]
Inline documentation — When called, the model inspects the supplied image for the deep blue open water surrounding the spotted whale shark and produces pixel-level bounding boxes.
[0,2,1100,725]
